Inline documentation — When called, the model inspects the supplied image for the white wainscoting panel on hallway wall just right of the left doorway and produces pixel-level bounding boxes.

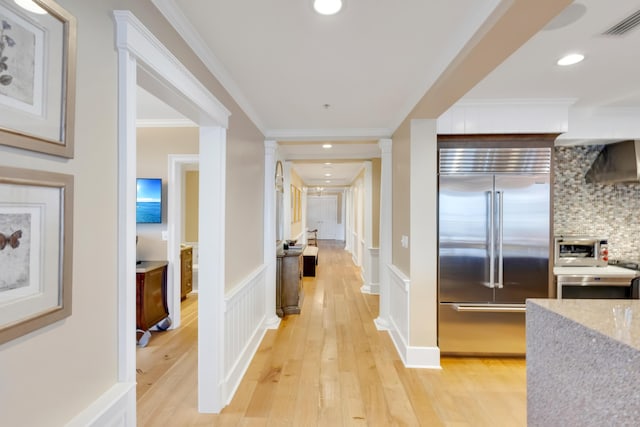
[223,265,266,404]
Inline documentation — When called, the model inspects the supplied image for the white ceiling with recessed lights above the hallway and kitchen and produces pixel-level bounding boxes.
[140,0,640,185]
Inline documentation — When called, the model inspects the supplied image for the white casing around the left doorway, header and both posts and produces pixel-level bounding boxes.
[113,10,230,419]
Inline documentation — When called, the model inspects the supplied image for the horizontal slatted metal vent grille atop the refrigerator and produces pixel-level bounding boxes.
[439,147,551,174]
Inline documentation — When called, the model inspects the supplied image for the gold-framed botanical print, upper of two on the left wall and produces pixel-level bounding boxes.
[0,0,76,158]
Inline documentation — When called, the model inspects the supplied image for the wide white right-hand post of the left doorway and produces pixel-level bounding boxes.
[198,127,229,413]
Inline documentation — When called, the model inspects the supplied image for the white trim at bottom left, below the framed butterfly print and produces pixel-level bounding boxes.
[66,382,136,427]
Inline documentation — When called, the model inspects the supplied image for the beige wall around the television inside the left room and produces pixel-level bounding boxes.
[136,127,199,260]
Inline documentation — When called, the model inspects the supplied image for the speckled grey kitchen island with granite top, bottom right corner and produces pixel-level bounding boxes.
[526,299,640,426]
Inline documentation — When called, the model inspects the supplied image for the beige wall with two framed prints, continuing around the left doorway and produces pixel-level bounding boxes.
[0,0,264,426]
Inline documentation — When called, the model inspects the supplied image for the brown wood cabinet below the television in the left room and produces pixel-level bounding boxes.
[136,261,169,331]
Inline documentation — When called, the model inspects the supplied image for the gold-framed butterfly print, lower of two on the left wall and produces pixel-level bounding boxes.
[0,166,73,344]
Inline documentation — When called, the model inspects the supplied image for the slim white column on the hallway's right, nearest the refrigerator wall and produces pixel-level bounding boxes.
[375,139,393,330]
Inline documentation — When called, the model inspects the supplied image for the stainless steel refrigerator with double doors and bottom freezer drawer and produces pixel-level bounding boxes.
[438,147,551,355]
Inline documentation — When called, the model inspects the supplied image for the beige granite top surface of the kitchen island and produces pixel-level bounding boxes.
[527,299,640,350]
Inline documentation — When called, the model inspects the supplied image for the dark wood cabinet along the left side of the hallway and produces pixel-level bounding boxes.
[276,249,303,317]
